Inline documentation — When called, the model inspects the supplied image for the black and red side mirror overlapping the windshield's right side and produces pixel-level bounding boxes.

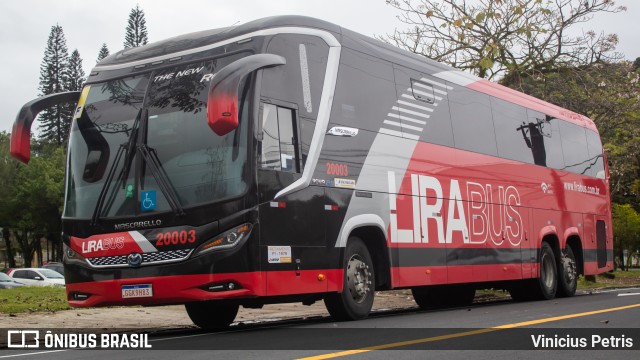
[207,54,287,136]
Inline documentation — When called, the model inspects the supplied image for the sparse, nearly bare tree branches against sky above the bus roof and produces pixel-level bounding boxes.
[381,0,626,79]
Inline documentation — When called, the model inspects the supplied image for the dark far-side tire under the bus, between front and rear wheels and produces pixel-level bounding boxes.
[411,285,476,309]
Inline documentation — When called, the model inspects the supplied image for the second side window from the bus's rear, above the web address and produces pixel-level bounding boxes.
[558,120,589,174]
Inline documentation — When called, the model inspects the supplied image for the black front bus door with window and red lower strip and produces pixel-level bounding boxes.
[258,99,327,296]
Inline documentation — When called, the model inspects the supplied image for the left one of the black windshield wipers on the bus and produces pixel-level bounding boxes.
[91,109,142,225]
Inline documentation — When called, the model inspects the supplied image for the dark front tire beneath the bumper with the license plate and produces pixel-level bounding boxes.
[184,300,240,329]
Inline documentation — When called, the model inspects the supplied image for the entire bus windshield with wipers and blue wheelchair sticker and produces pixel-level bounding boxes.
[64,56,248,218]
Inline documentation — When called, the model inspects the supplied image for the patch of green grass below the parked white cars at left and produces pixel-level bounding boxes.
[0,286,71,314]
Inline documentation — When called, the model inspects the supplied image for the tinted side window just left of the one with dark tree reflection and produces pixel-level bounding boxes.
[449,87,498,155]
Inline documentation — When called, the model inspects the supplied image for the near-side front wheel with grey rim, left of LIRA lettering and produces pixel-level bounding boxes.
[324,237,376,321]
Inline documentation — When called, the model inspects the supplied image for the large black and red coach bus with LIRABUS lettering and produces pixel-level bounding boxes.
[11,16,613,327]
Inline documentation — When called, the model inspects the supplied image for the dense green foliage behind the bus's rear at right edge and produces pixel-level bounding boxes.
[516,61,640,210]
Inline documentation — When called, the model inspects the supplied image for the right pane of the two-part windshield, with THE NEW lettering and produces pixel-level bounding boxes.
[142,55,249,214]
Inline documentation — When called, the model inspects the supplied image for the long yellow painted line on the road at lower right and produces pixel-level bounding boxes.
[298,304,640,360]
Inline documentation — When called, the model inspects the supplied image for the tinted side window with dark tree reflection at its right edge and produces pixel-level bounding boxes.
[491,98,535,164]
